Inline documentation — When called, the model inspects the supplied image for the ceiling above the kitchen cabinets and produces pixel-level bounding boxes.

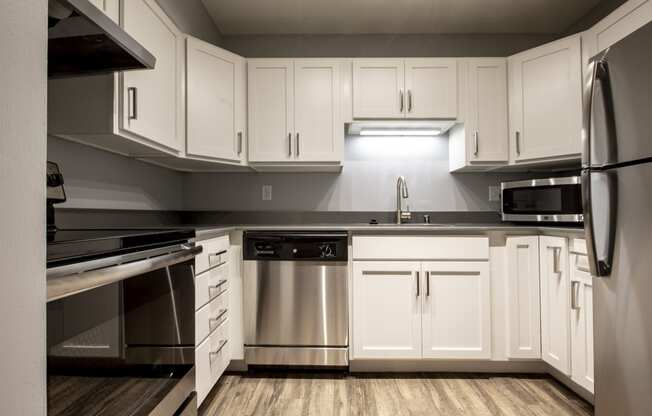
[202,0,600,35]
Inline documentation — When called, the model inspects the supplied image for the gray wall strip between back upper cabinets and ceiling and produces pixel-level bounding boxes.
[222,34,555,58]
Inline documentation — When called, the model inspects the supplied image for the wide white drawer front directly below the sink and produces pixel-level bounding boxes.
[353,236,489,260]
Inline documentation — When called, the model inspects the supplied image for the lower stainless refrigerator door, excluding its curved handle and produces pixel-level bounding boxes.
[587,163,652,416]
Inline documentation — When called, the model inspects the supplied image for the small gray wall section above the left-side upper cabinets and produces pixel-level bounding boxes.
[157,0,222,45]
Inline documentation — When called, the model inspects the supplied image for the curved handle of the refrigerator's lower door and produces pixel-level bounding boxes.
[582,170,618,277]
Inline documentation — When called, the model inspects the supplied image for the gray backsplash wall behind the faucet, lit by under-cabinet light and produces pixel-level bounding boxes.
[184,137,536,211]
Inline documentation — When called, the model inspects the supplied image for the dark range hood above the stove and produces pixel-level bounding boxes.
[48,0,156,78]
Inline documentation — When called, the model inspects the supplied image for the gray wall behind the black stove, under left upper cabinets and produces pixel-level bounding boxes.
[47,137,183,210]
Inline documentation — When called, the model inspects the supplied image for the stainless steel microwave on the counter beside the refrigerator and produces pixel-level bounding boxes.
[501,176,584,223]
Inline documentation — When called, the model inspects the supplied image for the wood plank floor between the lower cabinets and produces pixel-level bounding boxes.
[200,373,593,416]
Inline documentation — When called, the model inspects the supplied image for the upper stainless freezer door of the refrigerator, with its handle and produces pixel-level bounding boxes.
[582,23,652,168]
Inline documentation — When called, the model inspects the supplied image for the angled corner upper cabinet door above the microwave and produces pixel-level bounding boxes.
[509,35,582,162]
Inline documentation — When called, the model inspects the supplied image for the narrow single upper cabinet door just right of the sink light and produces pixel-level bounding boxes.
[467,59,509,163]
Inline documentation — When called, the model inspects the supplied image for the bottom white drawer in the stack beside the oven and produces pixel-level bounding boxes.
[195,319,231,404]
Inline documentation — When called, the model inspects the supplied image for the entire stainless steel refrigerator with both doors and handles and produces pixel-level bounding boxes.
[582,19,652,416]
